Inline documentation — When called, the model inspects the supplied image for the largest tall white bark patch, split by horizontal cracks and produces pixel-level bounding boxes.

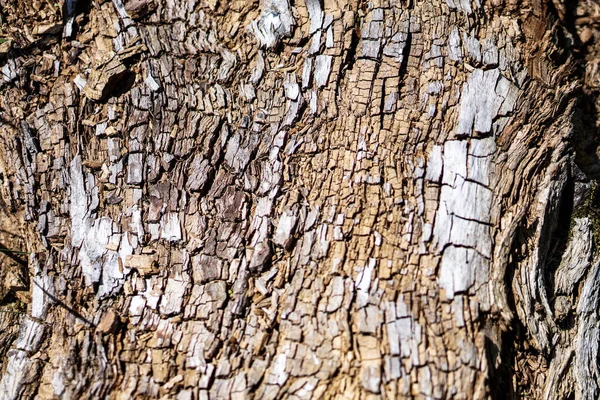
[427,138,496,309]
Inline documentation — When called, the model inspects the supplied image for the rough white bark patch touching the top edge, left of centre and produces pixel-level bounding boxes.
[248,0,295,48]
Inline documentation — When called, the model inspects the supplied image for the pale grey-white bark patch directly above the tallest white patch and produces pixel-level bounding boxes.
[456,69,500,135]
